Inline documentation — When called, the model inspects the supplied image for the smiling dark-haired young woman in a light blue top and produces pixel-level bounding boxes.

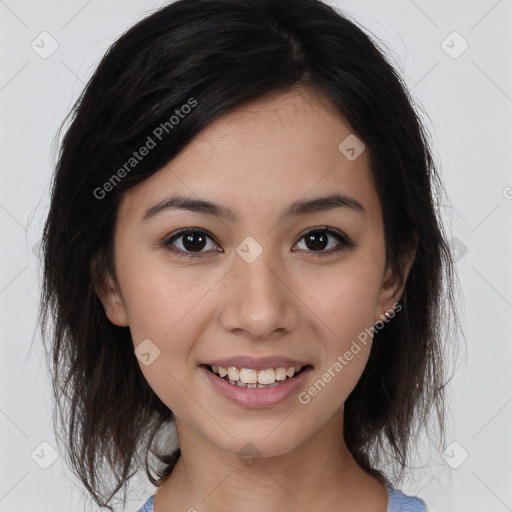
[38,0,454,512]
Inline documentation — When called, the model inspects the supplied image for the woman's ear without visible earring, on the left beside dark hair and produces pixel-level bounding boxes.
[90,250,129,327]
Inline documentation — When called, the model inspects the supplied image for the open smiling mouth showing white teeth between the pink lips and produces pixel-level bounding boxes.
[200,364,313,389]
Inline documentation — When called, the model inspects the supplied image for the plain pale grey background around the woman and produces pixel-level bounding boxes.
[0,0,512,512]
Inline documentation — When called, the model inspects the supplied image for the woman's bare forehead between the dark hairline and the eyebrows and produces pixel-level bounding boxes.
[120,90,379,226]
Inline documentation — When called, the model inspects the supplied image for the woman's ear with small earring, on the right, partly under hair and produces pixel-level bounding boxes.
[375,234,418,323]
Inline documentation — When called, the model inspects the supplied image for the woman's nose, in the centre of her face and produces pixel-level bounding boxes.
[218,244,300,340]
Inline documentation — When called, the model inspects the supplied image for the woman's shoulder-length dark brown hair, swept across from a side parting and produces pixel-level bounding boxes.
[40,0,456,510]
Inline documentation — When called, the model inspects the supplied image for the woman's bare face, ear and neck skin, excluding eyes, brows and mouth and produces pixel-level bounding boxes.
[97,90,414,512]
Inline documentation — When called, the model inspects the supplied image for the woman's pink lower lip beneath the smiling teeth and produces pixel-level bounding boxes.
[199,366,313,407]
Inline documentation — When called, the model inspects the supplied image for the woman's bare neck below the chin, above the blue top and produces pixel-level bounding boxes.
[154,409,387,512]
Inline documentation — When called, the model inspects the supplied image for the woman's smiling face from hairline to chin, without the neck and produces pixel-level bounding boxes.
[99,91,408,455]
